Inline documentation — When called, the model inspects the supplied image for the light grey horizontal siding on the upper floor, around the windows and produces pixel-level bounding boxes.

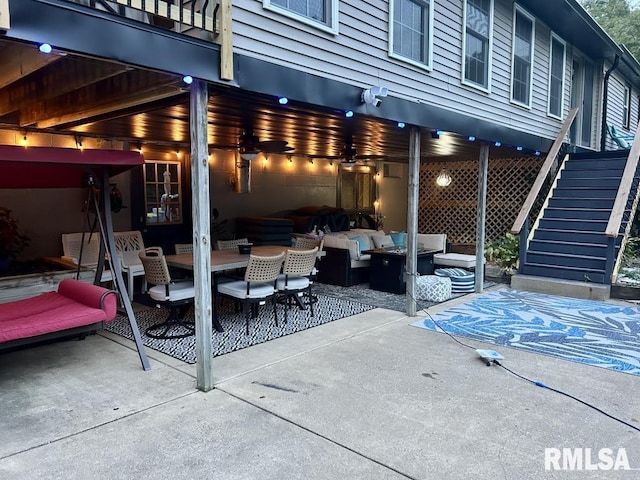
[233,0,588,142]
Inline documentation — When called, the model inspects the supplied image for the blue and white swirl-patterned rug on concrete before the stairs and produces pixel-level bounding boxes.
[412,290,640,375]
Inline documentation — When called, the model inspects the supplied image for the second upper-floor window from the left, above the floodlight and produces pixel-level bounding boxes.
[389,0,433,69]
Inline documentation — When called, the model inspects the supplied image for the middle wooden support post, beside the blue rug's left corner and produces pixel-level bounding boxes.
[406,127,420,317]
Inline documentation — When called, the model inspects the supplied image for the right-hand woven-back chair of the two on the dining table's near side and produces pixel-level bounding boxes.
[276,247,318,323]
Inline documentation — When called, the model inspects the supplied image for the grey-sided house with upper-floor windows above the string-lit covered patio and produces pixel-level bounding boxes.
[0,0,640,288]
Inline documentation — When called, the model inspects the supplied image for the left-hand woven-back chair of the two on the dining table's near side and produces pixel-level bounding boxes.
[218,253,284,335]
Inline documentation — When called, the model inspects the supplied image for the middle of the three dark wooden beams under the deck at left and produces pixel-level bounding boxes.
[0,57,128,116]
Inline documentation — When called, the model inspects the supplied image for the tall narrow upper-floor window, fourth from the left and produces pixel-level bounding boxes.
[511,5,536,108]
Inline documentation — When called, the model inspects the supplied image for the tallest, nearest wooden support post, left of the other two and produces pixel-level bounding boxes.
[190,80,213,392]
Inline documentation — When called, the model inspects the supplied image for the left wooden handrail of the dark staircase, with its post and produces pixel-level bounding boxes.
[511,107,579,270]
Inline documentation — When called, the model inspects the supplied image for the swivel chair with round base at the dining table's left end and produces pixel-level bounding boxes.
[139,247,196,340]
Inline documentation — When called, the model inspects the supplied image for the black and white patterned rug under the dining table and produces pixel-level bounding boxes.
[106,295,375,363]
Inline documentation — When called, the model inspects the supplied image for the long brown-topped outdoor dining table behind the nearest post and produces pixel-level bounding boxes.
[165,245,304,332]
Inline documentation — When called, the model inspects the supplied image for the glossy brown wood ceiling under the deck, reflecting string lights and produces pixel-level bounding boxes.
[0,41,516,162]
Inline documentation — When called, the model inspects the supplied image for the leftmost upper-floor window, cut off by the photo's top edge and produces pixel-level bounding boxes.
[262,0,338,34]
